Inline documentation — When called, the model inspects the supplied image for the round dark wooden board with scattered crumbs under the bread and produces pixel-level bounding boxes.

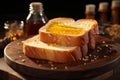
[4,36,120,80]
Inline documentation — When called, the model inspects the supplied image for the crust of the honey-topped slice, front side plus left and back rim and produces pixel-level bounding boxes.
[39,18,97,46]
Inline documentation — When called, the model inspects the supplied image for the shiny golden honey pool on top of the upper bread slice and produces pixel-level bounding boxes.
[46,23,85,35]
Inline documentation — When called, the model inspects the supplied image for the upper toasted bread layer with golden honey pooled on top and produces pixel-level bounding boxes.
[39,18,98,46]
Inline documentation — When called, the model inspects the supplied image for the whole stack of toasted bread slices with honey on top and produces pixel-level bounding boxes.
[22,17,99,63]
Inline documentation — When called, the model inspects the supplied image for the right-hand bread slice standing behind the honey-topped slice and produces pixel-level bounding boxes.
[77,19,99,49]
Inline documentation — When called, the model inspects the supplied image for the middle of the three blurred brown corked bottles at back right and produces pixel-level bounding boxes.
[98,2,110,36]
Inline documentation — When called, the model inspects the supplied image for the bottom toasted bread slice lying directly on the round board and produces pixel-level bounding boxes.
[22,35,82,63]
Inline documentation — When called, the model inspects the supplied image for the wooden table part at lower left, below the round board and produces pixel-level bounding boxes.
[0,57,26,80]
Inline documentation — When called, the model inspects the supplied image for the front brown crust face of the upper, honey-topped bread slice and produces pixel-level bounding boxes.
[39,31,88,46]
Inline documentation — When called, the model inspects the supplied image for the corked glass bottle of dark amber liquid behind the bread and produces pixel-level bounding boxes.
[24,2,48,37]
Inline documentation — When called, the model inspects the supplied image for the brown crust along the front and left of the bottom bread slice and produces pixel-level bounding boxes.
[22,35,82,63]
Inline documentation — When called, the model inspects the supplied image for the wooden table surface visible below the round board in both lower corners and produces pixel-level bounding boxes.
[0,52,120,80]
